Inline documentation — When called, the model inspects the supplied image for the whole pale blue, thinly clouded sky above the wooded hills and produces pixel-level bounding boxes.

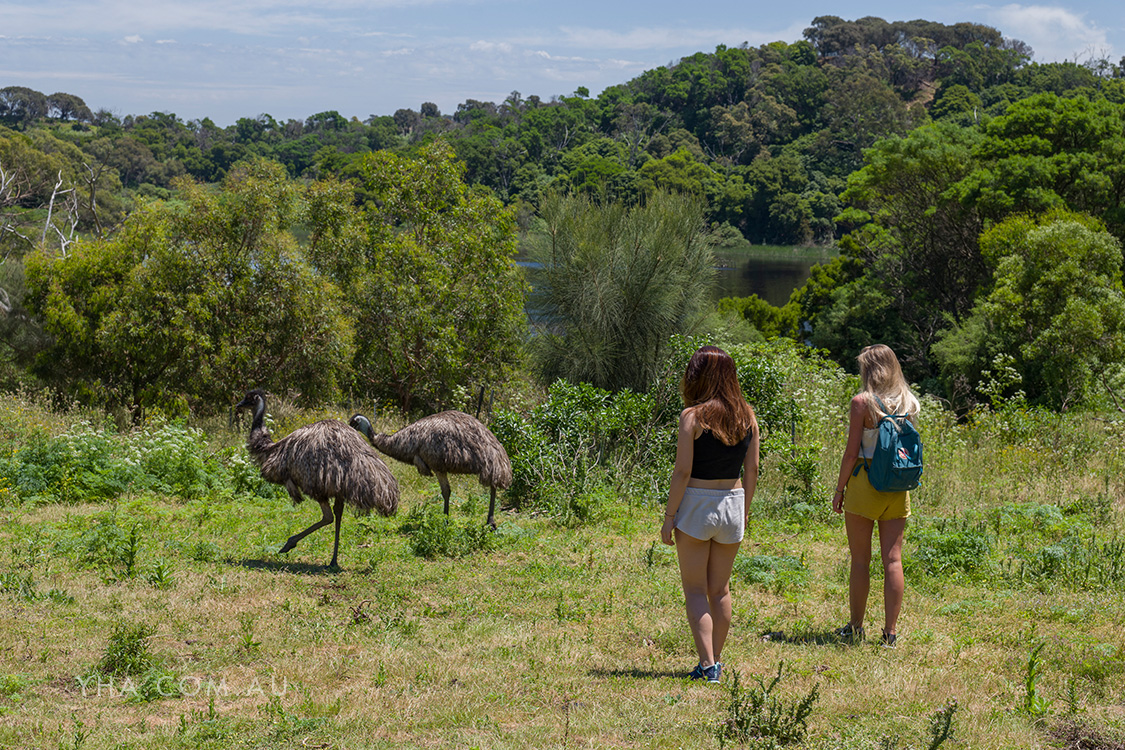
[0,0,1125,126]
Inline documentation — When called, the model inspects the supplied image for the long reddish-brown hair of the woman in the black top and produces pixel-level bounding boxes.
[680,346,758,445]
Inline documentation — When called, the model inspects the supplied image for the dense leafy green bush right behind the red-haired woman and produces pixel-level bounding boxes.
[491,336,824,522]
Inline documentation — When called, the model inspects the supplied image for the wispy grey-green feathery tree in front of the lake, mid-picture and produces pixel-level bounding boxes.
[532,191,714,390]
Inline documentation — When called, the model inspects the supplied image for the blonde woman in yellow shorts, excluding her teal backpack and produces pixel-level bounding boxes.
[833,344,919,648]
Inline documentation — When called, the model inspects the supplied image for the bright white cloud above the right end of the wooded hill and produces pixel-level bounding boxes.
[980,3,1113,62]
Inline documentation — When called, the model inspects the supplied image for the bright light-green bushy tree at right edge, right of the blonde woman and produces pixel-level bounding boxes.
[934,210,1125,409]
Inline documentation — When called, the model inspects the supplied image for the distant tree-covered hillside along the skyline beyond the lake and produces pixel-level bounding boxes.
[0,16,1125,249]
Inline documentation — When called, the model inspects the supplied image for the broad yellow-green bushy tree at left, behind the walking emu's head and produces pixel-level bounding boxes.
[27,161,352,419]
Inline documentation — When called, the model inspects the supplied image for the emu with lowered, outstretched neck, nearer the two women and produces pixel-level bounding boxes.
[348,412,512,527]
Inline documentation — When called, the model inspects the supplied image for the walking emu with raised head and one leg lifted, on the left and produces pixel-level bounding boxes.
[235,389,398,568]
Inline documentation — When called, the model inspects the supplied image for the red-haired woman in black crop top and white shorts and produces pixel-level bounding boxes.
[660,346,758,683]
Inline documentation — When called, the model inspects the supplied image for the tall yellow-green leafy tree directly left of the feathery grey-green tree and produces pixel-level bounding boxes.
[309,141,527,412]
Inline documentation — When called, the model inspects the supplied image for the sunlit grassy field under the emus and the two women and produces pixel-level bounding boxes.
[0,383,1125,750]
